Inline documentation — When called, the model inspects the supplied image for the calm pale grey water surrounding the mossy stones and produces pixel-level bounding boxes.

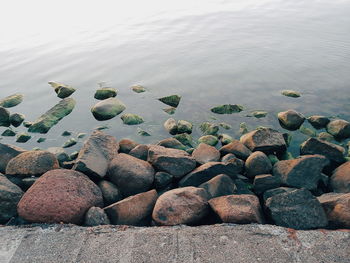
[0,0,350,156]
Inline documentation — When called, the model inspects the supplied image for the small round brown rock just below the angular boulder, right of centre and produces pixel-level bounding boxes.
[245,151,272,178]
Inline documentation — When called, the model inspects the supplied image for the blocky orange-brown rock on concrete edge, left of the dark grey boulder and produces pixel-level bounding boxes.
[209,194,264,224]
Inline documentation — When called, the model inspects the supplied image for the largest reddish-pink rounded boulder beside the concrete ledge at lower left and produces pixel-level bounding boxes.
[17,169,103,224]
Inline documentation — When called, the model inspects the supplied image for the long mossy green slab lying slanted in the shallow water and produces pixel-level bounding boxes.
[28,98,75,133]
